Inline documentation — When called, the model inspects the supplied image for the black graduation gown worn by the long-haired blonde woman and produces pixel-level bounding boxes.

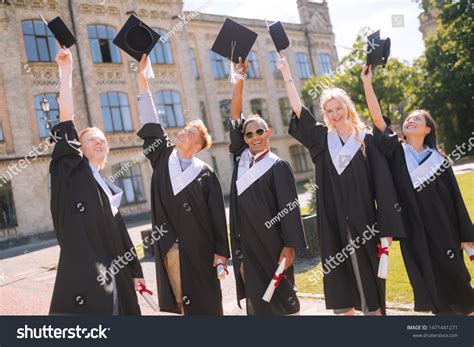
[289,107,404,314]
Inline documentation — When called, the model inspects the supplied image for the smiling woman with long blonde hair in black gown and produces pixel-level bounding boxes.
[277,55,404,315]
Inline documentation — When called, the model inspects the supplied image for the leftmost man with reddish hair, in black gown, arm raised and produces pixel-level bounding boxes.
[50,48,145,315]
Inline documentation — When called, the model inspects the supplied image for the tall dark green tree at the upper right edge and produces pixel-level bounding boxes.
[415,0,474,150]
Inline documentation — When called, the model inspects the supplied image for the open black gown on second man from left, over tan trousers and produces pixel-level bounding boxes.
[138,123,230,315]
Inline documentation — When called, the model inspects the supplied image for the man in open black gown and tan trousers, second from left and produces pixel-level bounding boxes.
[138,55,230,315]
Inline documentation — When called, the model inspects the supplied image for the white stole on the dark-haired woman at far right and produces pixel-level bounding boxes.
[402,143,444,189]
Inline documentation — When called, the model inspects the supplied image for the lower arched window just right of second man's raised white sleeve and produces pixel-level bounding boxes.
[156,90,184,128]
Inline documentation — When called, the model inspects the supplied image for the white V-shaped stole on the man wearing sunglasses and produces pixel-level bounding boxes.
[235,148,280,195]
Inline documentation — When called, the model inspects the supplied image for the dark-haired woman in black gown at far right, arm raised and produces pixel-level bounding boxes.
[361,66,474,314]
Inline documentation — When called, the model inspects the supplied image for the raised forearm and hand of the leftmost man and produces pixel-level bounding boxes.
[56,47,74,122]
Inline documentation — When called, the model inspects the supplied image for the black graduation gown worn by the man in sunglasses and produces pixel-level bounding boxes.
[230,121,307,315]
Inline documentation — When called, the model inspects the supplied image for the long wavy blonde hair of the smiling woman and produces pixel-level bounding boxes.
[319,88,368,156]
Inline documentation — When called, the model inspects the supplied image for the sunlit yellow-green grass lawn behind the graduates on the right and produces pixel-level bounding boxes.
[296,172,474,304]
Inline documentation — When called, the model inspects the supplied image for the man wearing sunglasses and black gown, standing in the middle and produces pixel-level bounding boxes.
[229,59,306,315]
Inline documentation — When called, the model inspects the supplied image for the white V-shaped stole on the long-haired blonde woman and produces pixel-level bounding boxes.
[327,130,366,175]
